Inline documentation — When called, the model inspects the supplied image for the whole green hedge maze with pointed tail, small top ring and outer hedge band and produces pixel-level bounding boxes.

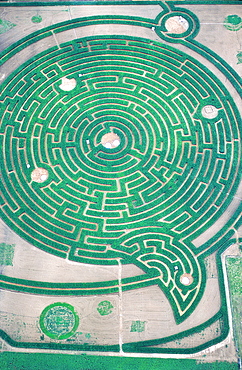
[0,1,241,354]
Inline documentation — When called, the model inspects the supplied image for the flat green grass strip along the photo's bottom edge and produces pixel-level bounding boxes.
[0,352,238,370]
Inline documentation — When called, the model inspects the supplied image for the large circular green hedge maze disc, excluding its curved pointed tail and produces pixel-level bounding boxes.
[1,36,239,263]
